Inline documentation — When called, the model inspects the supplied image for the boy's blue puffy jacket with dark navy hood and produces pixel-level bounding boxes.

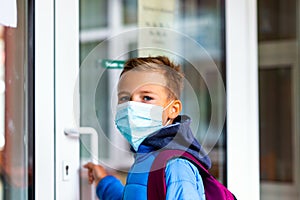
[96,116,211,200]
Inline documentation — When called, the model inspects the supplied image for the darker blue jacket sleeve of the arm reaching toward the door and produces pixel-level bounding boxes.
[96,176,124,200]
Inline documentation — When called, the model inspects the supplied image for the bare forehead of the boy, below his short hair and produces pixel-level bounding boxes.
[118,71,167,93]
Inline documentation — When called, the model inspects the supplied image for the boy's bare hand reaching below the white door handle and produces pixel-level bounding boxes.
[83,162,108,185]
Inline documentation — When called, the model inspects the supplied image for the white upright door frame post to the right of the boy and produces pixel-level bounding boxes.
[225,0,260,200]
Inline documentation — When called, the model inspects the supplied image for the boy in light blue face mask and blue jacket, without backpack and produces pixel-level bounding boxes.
[84,56,211,200]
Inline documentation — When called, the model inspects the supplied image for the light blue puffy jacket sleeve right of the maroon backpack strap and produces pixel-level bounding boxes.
[165,158,205,200]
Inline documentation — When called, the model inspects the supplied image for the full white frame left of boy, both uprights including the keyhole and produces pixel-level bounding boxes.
[35,0,80,199]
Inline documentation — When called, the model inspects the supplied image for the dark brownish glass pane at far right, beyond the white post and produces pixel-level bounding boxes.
[258,0,300,200]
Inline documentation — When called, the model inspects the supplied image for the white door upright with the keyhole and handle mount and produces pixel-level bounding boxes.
[54,0,80,200]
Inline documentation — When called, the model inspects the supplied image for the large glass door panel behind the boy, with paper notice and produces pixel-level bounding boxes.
[76,0,227,198]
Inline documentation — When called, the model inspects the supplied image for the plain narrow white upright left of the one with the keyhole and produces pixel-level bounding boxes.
[34,0,55,200]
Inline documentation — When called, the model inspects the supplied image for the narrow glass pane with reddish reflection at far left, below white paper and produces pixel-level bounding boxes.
[0,1,34,200]
